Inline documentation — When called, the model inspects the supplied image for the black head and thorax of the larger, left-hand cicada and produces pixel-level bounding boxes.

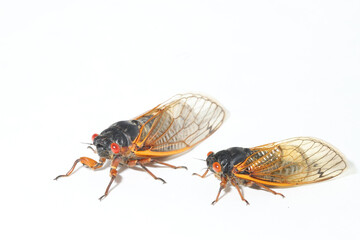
[94,120,142,158]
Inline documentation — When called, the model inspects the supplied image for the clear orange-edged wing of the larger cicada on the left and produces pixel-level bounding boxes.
[135,94,225,157]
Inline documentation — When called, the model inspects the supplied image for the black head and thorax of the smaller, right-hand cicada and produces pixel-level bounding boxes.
[206,147,252,176]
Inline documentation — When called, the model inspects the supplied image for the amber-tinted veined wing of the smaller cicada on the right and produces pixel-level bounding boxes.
[236,137,346,186]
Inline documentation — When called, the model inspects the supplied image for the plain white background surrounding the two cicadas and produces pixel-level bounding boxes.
[0,0,360,239]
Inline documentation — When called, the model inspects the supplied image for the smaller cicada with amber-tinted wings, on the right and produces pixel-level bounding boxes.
[194,137,346,204]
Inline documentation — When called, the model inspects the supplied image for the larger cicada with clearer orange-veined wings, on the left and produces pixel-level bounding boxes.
[55,94,225,200]
